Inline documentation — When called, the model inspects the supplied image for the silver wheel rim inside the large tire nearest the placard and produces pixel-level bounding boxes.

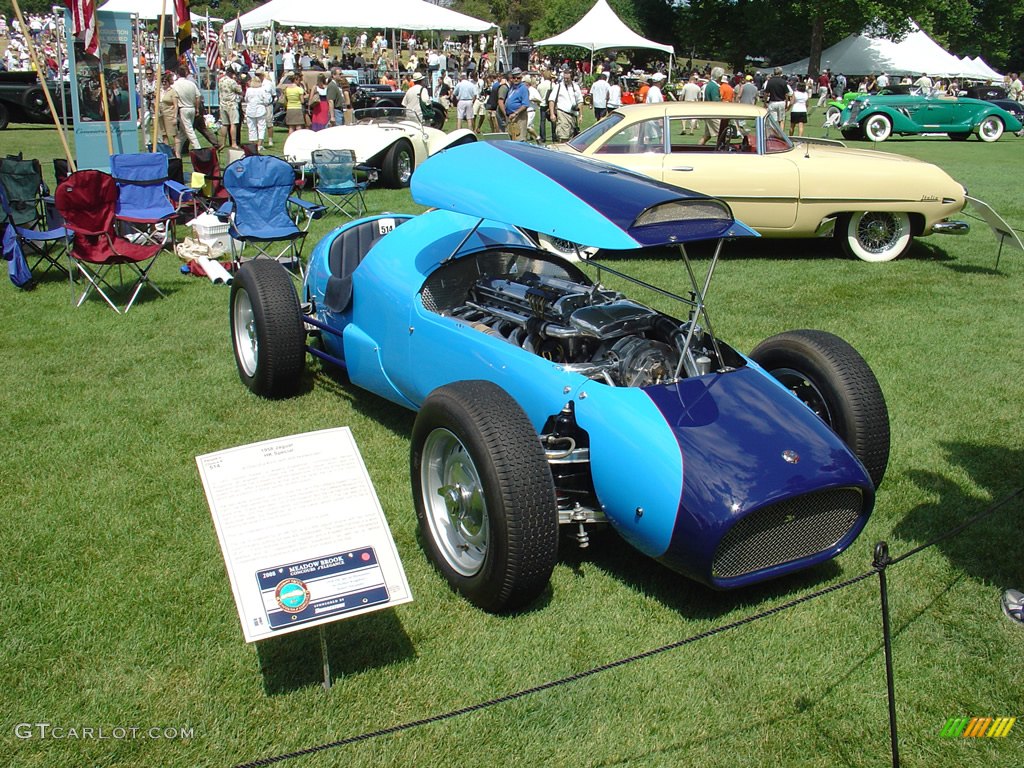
[420,429,490,577]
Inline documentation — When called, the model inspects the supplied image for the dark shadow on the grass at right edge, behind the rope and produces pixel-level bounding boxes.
[892,442,1024,588]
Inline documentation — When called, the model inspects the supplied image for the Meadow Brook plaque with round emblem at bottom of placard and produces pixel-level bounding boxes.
[256,547,389,630]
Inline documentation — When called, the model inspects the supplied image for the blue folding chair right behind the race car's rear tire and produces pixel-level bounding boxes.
[217,155,325,274]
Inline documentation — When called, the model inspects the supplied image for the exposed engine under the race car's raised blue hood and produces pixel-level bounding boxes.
[445,271,721,387]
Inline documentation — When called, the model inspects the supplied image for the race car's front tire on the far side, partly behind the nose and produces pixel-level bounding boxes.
[751,330,889,487]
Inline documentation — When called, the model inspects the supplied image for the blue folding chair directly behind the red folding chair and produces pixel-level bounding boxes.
[111,153,195,250]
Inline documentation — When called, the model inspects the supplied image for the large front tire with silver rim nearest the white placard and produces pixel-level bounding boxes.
[411,381,558,612]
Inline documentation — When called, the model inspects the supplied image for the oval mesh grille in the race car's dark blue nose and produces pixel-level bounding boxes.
[712,488,863,579]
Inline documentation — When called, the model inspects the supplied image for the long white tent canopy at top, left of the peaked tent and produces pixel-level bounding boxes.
[224,0,495,35]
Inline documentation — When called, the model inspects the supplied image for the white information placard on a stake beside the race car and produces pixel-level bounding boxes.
[196,427,413,642]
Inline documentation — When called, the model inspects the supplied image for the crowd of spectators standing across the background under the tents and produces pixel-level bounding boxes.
[0,13,1024,150]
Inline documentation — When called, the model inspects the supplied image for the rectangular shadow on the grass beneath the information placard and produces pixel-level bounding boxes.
[256,608,416,695]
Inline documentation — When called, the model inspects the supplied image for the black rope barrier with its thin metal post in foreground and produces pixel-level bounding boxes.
[234,487,1024,768]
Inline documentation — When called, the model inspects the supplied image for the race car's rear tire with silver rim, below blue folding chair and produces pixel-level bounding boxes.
[230,259,306,399]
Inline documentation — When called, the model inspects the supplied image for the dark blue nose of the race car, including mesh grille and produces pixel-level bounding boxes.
[644,368,874,589]
